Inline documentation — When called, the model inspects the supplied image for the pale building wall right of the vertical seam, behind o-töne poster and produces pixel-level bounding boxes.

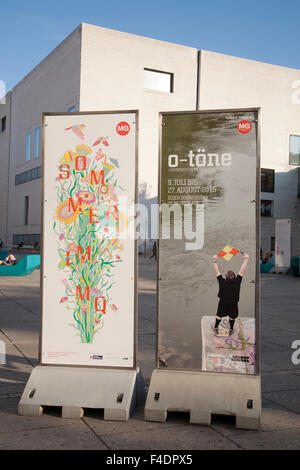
[199,51,300,255]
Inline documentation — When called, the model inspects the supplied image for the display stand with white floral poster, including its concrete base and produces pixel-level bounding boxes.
[19,111,144,420]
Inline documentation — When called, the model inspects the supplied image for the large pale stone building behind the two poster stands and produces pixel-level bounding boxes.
[0,24,300,255]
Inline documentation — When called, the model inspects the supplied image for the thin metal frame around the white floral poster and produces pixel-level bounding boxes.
[39,110,139,370]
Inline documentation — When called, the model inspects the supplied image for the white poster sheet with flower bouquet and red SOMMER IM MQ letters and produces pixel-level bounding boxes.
[42,113,136,367]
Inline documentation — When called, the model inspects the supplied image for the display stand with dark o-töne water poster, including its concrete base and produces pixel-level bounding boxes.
[145,108,261,429]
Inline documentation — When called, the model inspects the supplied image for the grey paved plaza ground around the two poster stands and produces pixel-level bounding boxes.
[0,258,300,450]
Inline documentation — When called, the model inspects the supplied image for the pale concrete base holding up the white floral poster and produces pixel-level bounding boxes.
[19,366,145,421]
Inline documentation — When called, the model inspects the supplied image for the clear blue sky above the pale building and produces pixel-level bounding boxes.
[0,0,300,90]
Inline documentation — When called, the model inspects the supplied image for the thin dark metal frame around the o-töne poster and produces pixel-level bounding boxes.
[155,107,261,377]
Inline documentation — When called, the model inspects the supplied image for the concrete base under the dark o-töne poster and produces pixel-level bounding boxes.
[145,369,261,430]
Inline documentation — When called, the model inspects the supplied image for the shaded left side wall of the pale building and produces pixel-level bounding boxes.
[6,27,81,245]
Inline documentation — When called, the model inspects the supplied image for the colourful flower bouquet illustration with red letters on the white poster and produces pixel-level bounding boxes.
[53,139,123,343]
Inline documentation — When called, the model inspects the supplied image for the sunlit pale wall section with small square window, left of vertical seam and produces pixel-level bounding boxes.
[80,24,198,206]
